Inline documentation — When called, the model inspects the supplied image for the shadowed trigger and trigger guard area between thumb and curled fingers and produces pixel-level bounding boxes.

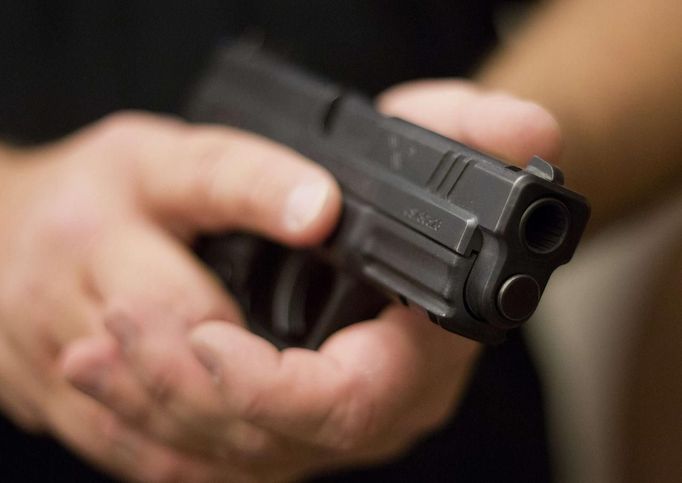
[196,234,389,349]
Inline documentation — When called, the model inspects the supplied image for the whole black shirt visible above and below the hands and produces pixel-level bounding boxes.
[0,0,550,482]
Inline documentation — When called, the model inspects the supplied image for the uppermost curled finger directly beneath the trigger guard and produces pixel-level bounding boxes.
[191,312,475,450]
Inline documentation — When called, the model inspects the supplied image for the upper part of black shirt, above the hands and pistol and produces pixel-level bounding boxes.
[0,0,495,141]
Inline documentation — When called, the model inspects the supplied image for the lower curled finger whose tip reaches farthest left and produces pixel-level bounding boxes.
[62,338,320,481]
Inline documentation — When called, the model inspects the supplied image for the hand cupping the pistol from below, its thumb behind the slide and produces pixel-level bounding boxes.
[58,81,560,481]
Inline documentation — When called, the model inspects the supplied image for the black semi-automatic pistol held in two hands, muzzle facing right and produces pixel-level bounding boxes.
[188,45,589,348]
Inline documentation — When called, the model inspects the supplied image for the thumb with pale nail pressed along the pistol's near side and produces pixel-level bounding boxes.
[140,126,341,244]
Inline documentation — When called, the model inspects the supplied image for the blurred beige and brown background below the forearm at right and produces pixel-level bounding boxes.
[528,192,682,483]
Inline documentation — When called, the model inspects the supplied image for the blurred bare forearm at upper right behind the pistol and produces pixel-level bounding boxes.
[480,0,682,231]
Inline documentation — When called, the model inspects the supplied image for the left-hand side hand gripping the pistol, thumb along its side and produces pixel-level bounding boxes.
[0,113,340,481]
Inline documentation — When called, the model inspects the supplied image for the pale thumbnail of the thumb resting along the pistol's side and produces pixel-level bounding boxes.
[284,179,330,232]
